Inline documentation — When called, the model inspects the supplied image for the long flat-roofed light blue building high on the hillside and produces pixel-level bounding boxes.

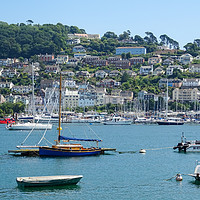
[116,47,146,55]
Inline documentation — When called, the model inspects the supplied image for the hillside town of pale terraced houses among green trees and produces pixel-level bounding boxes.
[0,22,200,121]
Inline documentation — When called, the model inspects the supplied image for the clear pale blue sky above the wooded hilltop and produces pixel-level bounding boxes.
[0,0,200,48]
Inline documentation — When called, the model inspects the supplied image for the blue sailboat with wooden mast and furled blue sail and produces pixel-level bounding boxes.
[39,74,101,157]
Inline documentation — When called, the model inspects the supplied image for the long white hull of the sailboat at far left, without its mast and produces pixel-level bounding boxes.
[6,122,52,130]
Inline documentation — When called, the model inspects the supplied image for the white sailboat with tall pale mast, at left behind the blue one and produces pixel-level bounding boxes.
[6,65,52,130]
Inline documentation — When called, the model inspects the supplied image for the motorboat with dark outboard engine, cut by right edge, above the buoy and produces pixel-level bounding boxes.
[173,135,200,152]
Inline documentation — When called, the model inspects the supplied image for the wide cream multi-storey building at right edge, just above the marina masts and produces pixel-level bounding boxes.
[172,88,200,102]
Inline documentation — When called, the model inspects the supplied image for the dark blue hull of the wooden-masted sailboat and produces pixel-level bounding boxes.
[39,147,101,157]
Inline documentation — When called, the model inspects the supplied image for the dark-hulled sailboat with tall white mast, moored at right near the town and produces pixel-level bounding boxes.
[157,79,184,125]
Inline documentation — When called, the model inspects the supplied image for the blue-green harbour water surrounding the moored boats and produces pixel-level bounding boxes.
[0,124,200,200]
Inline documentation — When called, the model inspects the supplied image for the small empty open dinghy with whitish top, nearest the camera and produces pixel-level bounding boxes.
[16,175,83,187]
